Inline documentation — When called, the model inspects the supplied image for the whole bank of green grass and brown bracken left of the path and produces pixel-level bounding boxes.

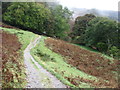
[0,28,37,88]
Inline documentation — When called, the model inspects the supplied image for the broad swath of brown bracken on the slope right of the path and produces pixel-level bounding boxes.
[45,38,118,88]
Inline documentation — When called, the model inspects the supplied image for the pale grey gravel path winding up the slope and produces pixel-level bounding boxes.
[24,36,66,88]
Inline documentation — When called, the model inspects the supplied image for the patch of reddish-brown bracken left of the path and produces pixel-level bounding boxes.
[0,32,26,88]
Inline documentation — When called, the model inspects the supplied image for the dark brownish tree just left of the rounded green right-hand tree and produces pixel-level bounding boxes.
[71,14,95,43]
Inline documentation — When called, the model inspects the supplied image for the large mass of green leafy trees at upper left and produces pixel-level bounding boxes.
[3,2,72,39]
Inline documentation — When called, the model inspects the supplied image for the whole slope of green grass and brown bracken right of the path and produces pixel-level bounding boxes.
[32,37,118,88]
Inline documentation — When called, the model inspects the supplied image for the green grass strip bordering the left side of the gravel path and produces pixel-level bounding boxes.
[0,27,38,88]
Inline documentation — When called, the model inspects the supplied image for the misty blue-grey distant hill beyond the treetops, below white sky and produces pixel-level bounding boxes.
[71,8,120,21]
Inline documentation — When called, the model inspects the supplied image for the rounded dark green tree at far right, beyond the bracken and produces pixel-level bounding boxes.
[85,17,118,52]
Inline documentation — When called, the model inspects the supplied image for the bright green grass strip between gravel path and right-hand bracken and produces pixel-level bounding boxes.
[31,37,98,88]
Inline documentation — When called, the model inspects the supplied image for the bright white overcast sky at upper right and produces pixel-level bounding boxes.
[57,0,120,11]
